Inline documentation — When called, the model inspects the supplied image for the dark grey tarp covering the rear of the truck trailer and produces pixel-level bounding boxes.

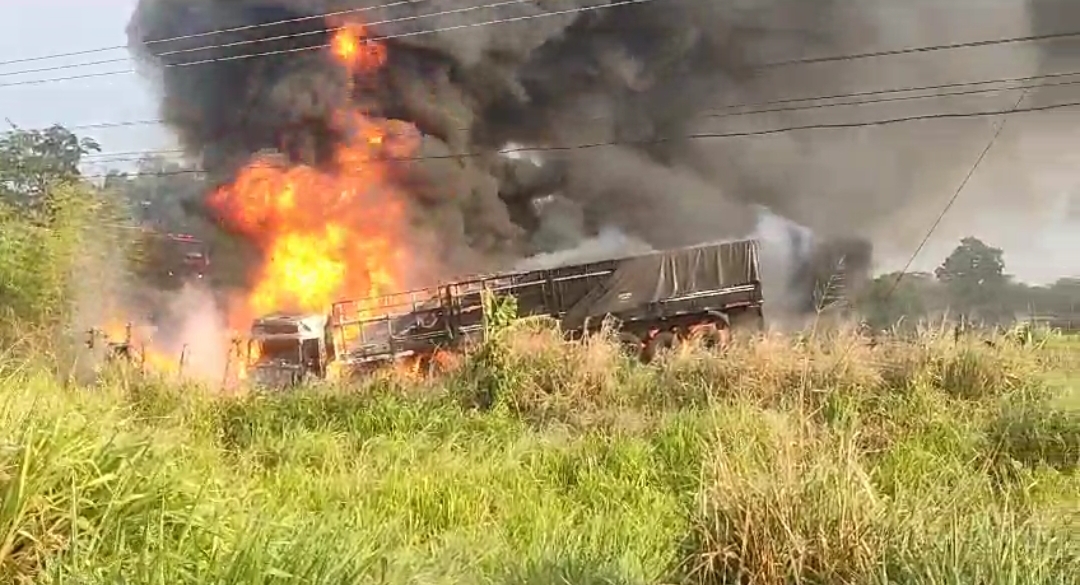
[563,240,760,328]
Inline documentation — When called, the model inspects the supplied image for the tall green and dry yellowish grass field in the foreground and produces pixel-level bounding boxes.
[0,330,1080,585]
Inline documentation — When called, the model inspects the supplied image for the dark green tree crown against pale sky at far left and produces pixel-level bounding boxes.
[0,125,100,209]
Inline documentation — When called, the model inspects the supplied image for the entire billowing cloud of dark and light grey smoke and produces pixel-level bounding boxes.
[129,0,1080,287]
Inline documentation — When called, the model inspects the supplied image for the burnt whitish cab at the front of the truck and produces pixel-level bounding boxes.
[246,313,332,387]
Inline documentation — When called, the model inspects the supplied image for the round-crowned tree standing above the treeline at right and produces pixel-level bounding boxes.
[934,236,1010,318]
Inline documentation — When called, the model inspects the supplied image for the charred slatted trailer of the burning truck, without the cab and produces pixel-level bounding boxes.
[326,240,765,371]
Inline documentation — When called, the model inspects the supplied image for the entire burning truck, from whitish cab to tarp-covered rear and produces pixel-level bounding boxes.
[238,240,866,386]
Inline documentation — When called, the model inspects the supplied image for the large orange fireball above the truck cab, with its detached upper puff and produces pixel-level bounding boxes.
[208,24,417,327]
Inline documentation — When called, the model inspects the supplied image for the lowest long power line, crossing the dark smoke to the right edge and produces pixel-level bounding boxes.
[78,97,1080,178]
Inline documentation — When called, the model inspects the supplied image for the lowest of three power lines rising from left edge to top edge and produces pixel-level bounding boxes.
[0,0,654,87]
